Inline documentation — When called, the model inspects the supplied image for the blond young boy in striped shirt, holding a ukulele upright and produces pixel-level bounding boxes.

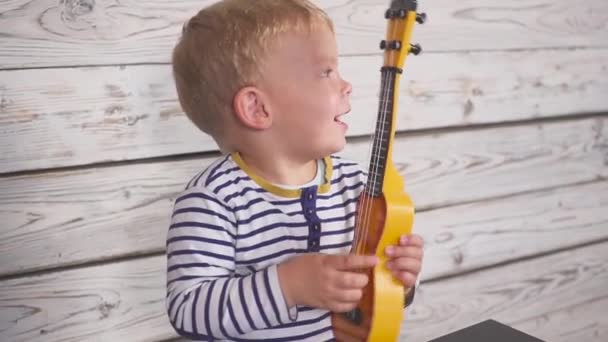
[167,0,422,341]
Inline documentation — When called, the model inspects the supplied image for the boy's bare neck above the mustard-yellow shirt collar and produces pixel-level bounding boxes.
[239,152,317,185]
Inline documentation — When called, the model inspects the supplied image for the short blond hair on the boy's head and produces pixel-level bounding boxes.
[172,0,333,147]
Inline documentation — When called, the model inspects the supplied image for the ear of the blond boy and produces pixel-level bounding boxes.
[233,86,272,130]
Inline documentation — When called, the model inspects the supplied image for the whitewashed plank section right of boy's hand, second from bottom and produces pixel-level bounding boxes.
[406,181,608,279]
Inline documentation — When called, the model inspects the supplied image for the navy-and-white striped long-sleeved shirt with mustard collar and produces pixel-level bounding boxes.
[166,153,366,342]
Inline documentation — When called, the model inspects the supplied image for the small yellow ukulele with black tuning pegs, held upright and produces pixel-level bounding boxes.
[332,0,426,342]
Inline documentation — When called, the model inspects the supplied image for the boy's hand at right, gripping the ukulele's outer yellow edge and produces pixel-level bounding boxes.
[386,234,424,288]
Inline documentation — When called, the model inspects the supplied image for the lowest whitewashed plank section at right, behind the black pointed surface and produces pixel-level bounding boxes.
[402,240,608,342]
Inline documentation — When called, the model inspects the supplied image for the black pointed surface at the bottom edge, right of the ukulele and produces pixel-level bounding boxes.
[429,320,544,342]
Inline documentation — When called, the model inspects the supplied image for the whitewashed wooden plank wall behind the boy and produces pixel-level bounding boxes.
[0,0,608,342]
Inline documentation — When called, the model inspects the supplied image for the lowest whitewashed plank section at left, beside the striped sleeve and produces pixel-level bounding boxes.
[0,255,174,342]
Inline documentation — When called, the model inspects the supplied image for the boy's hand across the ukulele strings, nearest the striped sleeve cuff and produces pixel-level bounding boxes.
[278,253,378,312]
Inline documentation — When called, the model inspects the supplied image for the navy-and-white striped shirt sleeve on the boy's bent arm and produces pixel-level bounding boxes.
[166,187,297,340]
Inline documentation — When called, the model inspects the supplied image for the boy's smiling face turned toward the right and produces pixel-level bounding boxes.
[263,26,351,158]
